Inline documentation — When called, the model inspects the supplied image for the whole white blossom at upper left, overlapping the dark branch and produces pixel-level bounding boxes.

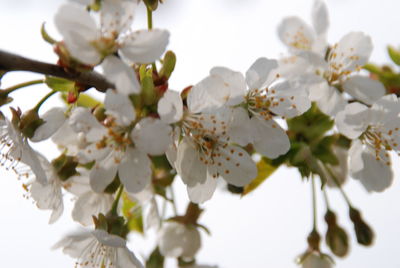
[55,0,169,94]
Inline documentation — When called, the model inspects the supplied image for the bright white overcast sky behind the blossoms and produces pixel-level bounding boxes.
[0,0,400,268]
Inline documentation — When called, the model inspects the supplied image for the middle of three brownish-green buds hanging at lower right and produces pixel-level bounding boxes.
[325,210,349,257]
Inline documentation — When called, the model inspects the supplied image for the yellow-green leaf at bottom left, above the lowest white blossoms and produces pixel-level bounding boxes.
[122,193,143,234]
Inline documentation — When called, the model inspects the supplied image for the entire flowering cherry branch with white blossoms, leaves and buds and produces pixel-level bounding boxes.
[0,0,400,268]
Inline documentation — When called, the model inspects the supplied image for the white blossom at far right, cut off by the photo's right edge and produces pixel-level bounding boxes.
[336,94,400,192]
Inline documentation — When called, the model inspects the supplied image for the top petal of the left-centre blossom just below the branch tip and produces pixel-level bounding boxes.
[104,89,136,126]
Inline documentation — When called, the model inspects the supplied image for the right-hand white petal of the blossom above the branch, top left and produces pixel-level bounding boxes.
[119,29,169,63]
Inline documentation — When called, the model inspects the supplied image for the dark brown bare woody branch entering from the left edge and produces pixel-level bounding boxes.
[0,50,115,92]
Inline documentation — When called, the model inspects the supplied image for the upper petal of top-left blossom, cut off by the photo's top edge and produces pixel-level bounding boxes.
[100,0,138,35]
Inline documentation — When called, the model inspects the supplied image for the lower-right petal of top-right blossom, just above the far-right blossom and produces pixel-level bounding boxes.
[343,75,386,104]
